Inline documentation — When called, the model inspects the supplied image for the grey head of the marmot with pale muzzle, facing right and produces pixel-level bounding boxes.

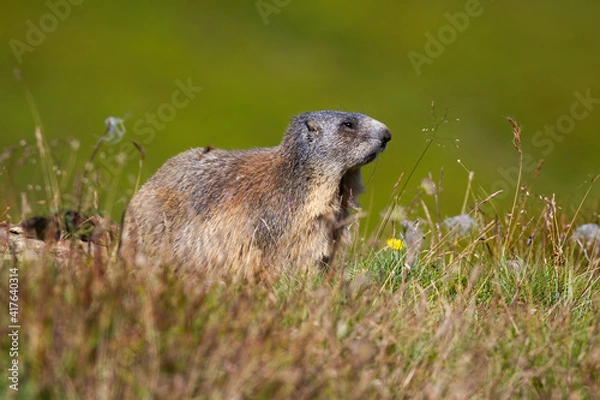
[282,111,392,174]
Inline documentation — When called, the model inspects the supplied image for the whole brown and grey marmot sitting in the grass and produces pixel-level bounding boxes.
[120,111,392,274]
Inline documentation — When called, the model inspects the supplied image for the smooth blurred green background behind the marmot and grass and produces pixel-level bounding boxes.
[0,0,600,228]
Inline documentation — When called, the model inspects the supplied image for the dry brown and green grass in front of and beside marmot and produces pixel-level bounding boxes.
[0,120,600,399]
